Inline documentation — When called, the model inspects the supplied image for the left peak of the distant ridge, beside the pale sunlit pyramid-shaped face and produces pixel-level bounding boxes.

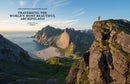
[34,25,64,46]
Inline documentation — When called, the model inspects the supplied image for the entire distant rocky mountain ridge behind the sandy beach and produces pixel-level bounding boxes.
[34,26,94,51]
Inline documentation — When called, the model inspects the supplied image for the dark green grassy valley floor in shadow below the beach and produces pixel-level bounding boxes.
[0,57,75,84]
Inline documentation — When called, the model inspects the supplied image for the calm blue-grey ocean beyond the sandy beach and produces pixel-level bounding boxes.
[0,31,46,53]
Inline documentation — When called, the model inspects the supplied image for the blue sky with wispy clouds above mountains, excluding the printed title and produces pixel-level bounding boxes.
[0,0,130,31]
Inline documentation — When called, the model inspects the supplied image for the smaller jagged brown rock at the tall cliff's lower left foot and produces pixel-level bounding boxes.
[65,61,88,84]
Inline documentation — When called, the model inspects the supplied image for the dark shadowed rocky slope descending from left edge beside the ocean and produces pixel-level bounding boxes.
[0,35,30,63]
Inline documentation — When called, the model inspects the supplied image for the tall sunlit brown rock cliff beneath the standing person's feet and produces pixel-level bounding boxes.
[65,20,130,84]
